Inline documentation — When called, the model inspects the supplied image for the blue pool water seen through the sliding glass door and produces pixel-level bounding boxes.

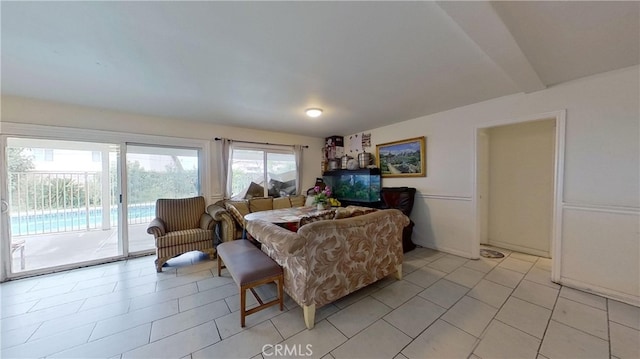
[11,203,156,236]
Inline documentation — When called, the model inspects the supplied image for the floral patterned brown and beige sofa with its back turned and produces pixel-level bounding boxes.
[247,209,409,329]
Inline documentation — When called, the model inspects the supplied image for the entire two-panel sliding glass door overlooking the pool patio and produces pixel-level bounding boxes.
[0,136,202,277]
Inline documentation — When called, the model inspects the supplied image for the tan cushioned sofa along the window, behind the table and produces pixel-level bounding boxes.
[207,195,306,242]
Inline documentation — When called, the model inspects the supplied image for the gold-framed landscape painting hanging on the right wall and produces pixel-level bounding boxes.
[376,136,427,177]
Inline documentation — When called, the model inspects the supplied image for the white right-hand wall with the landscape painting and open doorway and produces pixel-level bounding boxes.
[345,66,640,305]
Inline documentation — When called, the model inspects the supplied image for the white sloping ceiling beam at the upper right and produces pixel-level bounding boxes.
[437,1,546,92]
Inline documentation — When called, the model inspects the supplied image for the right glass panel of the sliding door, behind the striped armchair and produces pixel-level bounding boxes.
[126,145,200,252]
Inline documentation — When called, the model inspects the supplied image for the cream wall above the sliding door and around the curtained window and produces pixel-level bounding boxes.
[0,96,324,202]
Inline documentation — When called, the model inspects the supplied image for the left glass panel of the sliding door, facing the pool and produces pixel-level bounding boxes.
[2,137,123,274]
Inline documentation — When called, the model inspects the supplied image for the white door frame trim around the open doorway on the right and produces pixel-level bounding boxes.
[471,110,566,282]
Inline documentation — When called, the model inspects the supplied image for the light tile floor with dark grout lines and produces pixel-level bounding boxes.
[0,248,640,359]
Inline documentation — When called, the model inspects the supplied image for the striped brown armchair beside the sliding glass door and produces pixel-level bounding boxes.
[147,197,216,272]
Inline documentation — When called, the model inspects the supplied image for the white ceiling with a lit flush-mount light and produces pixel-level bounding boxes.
[0,1,640,137]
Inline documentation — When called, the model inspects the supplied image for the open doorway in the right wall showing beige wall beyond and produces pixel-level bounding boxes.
[473,111,565,280]
